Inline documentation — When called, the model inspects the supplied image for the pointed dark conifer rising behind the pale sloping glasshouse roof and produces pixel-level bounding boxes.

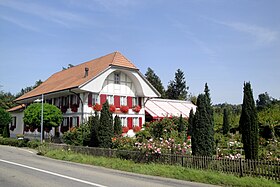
[166,69,189,100]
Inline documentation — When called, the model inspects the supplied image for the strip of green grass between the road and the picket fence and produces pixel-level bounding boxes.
[41,150,279,187]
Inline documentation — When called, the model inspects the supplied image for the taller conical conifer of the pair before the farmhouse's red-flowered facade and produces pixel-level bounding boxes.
[97,101,114,148]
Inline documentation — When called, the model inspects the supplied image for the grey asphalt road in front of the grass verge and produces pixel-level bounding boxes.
[0,146,217,187]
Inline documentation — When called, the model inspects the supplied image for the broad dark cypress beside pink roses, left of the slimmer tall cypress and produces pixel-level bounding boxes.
[191,84,214,156]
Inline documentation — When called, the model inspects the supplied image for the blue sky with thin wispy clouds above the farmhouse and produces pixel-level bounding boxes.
[0,0,280,104]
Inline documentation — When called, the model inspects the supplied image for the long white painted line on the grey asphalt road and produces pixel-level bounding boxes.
[0,159,107,187]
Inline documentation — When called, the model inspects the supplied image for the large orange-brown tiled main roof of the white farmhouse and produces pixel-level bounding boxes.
[16,52,137,101]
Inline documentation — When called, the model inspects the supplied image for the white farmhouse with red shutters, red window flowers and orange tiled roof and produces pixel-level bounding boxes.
[8,52,195,136]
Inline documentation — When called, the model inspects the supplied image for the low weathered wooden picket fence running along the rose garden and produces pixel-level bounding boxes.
[49,144,280,181]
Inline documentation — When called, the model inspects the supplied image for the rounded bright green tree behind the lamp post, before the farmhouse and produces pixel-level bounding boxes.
[23,103,63,133]
